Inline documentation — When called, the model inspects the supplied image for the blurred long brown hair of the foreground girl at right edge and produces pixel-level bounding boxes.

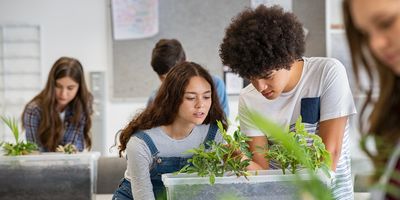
[342,0,400,178]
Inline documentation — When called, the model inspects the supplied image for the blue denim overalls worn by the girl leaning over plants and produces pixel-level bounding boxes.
[113,123,218,200]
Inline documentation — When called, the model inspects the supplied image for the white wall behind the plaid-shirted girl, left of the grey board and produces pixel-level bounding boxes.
[0,0,144,156]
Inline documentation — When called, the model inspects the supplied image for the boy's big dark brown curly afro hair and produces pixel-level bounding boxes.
[220,5,305,78]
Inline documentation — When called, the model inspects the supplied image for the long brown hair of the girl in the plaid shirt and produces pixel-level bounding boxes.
[22,57,93,151]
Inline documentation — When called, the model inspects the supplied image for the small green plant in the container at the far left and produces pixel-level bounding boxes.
[0,116,38,156]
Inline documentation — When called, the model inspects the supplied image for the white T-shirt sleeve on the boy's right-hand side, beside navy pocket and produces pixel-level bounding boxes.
[320,59,356,121]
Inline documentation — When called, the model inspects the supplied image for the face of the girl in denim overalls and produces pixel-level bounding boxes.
[176,76,212,125]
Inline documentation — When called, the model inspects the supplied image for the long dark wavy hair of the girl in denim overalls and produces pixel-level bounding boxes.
[119,62,228,156]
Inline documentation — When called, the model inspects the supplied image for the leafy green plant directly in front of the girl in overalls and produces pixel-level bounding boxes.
[177,121,251,184]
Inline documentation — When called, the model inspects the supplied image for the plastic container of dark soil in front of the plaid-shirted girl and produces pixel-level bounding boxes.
[0,152,100,200]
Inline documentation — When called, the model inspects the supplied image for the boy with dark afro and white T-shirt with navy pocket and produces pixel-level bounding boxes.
[220,5,356,199]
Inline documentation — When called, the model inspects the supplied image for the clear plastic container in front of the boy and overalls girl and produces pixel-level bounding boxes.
[162,170,331,200]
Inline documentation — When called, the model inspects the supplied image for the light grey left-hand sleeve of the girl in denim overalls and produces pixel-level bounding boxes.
[126,137,155,200]
